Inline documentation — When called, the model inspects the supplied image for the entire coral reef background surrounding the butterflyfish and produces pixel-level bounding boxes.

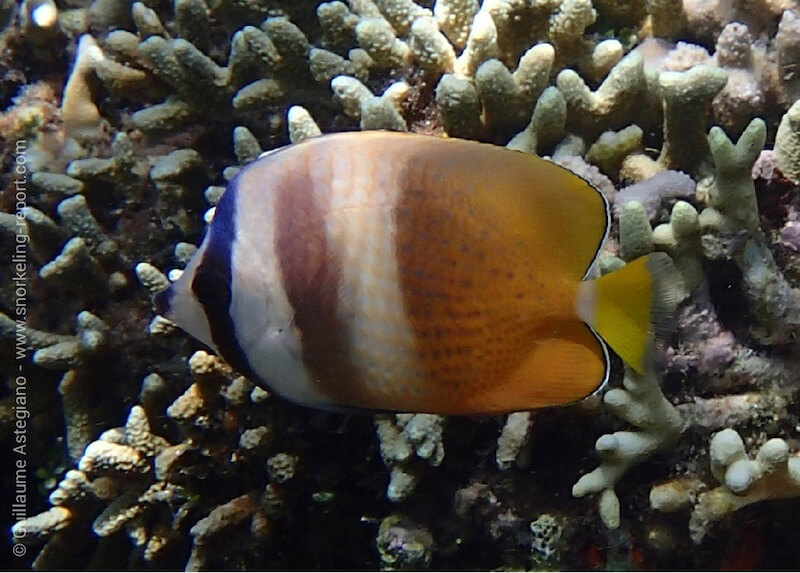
[0,0,800,570]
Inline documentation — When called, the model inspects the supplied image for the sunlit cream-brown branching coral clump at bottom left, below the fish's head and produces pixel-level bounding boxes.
[12,346,304,570]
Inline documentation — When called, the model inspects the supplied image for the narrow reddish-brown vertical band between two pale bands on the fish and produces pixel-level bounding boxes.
[275,148,357,405]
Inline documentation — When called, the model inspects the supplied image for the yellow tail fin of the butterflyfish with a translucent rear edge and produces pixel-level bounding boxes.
[586,253,685,373]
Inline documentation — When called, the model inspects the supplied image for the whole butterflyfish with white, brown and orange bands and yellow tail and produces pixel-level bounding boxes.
[154,131,681,415]
